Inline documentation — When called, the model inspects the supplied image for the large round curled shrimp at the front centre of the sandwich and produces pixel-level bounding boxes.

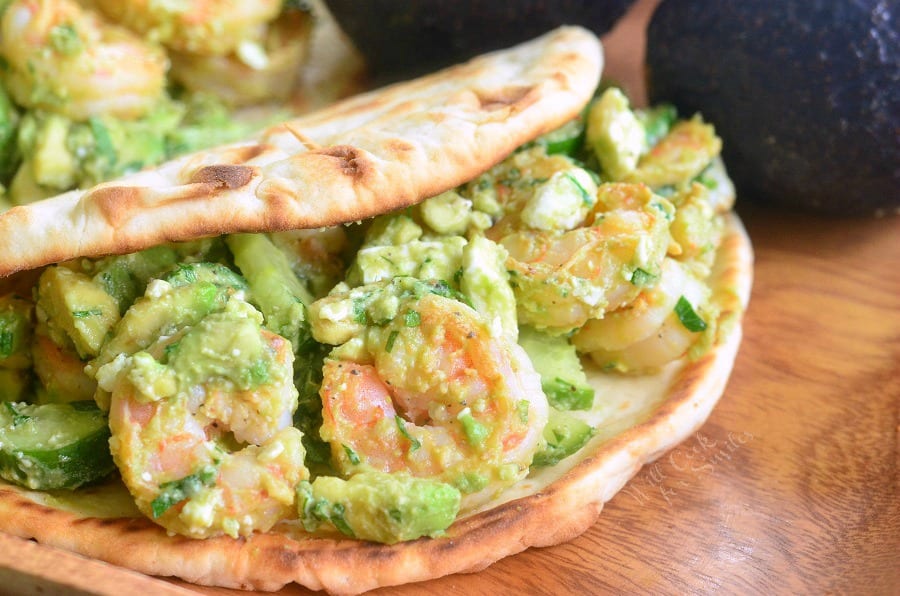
[311,278,549,509]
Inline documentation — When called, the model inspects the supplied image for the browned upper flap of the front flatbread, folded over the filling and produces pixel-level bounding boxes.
[0,27,603,277]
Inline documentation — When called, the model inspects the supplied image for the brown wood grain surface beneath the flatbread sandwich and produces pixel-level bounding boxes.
[0,0,900,595]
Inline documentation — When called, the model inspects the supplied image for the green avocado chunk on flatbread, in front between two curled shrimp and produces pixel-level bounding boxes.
[297,472,461,544]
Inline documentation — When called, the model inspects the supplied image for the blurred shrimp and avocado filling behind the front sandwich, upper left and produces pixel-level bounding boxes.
[0,0,313,210]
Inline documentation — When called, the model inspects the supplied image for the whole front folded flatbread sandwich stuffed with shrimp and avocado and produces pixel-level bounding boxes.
[0,27,752,593]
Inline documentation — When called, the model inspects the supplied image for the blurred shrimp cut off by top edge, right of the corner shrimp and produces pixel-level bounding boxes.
[95,0,282,56]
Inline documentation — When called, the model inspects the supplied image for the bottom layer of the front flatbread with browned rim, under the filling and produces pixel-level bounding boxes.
[0,214,753,594]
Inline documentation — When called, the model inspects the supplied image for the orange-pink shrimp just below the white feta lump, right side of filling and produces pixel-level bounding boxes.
[486,179,674,333]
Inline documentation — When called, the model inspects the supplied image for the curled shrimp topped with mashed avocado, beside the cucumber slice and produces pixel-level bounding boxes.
[105,300,309,538]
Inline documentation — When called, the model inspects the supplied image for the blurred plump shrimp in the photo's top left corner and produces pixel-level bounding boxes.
[0,0,168,120]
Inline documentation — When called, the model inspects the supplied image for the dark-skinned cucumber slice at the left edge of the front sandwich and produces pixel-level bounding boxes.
[0,401,115,490]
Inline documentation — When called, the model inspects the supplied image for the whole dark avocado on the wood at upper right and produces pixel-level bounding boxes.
[647,0,900,215]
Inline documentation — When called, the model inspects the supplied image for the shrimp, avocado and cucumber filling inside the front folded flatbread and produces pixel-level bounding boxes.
[0,89,734,543]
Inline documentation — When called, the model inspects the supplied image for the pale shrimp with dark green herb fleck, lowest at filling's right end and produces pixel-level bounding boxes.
[572,258,710,372]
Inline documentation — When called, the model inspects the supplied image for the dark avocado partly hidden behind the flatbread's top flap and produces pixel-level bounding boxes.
[326,0,634,82]
